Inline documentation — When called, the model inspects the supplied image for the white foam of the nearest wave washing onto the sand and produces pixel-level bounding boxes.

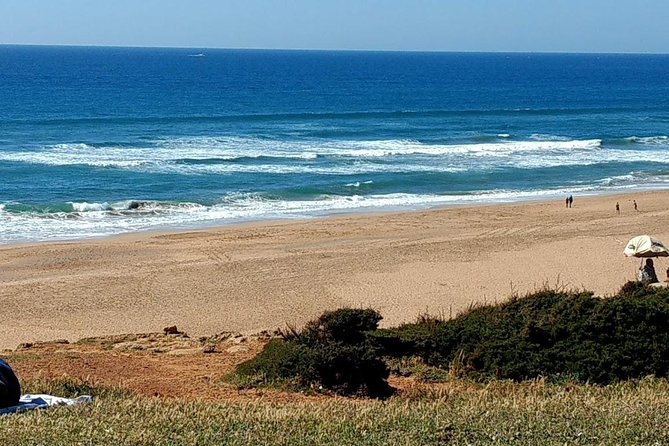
[0,182,636,243]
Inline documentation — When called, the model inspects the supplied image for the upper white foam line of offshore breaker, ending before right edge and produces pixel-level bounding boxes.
[0,137,601,168]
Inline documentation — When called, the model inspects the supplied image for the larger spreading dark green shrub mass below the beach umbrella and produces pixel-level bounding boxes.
[374,282,669,384]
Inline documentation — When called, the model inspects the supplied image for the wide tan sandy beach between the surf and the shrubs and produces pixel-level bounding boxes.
[0,192,669,348]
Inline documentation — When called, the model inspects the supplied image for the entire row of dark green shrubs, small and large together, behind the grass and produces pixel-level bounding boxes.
[236,282,669,396]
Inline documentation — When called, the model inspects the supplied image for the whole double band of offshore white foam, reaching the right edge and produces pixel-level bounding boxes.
[0,137,667,179]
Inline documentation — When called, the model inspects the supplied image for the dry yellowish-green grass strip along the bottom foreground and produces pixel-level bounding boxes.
[0,379,669,445]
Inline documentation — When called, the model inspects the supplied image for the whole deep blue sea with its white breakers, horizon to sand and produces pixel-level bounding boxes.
[0,46,669,243]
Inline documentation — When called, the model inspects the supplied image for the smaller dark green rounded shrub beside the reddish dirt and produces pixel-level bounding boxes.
[235,308,391,397]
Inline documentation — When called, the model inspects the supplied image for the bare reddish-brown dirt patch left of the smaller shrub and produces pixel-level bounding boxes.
[2,334,332,402]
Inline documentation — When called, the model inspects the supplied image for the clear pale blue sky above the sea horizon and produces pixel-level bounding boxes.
[0,0,669,53]
